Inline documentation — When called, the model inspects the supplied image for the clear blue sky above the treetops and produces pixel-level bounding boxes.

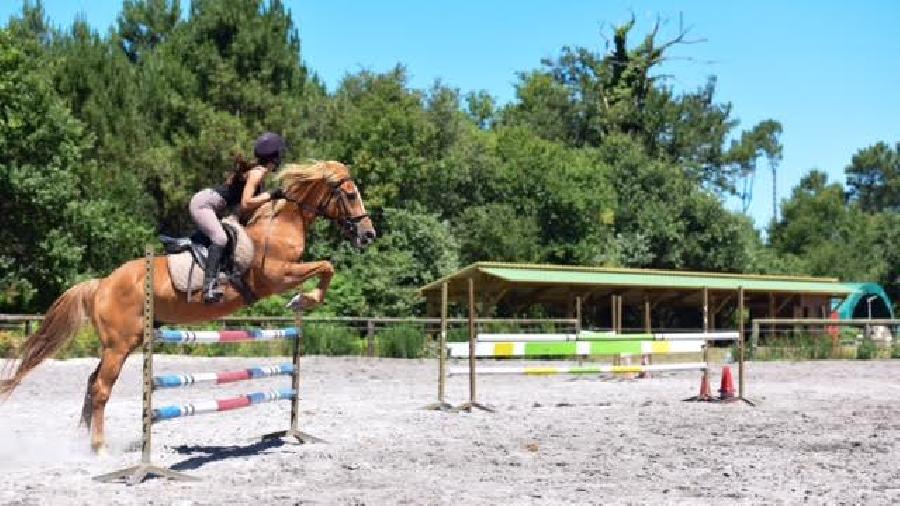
[0,0,900,226]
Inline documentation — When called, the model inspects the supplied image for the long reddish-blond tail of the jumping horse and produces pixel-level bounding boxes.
[0,279,100,396]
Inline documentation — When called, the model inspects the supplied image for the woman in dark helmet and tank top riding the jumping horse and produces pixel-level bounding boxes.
[190,132,284,304]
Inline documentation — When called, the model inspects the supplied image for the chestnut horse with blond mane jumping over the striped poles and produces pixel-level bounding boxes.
[0,162,375,451]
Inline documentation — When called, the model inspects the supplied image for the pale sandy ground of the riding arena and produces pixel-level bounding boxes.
[0,356,900,505]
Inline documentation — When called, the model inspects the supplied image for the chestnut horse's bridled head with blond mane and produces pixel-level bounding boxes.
[278,161,377,248]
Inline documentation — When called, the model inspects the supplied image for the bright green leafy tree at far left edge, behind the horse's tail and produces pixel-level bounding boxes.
[0,30,149,310]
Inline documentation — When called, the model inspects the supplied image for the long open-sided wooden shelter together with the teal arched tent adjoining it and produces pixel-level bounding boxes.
[421,262,893,331]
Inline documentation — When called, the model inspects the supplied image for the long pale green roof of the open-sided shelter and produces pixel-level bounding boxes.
[422,263,855,295]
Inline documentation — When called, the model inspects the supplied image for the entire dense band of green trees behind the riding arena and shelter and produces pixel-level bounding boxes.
[0,0,900,315]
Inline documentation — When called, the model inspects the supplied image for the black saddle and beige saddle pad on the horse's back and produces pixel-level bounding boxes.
[159,216,258,304]
